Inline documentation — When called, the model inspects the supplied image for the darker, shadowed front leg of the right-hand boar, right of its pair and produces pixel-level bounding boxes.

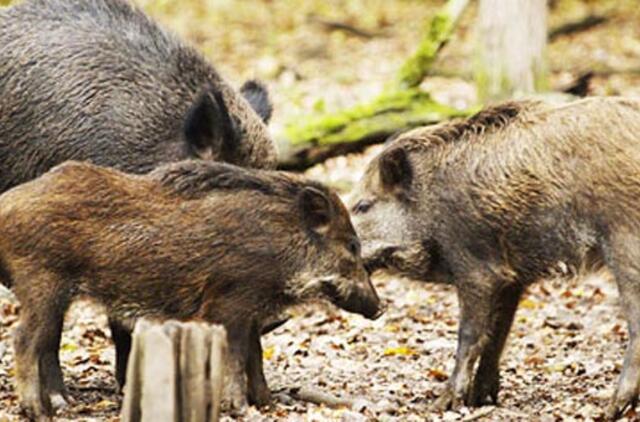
[471,284,522,406]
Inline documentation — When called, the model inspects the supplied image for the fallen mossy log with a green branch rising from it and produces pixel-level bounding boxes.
[280,0,469,170]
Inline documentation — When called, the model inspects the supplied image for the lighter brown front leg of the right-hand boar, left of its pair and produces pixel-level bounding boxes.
[434,280,493,411]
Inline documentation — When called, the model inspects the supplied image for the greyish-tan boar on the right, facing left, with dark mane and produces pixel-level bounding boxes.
[352,98,640,417]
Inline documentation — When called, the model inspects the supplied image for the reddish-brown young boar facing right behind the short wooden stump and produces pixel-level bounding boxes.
[0,161,381,416]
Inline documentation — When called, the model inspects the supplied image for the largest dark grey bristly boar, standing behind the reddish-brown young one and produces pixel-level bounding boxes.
[0,0,276,385]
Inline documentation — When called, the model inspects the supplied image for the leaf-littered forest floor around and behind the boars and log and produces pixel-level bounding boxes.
[0,0,640,422]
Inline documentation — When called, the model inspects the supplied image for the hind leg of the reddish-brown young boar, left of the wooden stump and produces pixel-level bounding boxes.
[14,277,68,418]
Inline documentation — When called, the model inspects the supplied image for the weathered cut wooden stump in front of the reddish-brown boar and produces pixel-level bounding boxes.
[122,320,227,422]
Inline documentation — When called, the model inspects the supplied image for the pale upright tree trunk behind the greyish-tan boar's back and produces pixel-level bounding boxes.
[475,0,547,99]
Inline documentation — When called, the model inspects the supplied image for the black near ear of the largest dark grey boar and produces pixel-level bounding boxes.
[183,88,237,159]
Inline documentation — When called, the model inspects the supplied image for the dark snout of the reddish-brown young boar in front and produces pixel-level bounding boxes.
[322,280,386,319]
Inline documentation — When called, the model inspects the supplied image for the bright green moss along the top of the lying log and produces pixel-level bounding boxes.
[285,88,466,145]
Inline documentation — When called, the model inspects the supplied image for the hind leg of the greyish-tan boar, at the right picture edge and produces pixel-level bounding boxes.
[605,231,640,419]
